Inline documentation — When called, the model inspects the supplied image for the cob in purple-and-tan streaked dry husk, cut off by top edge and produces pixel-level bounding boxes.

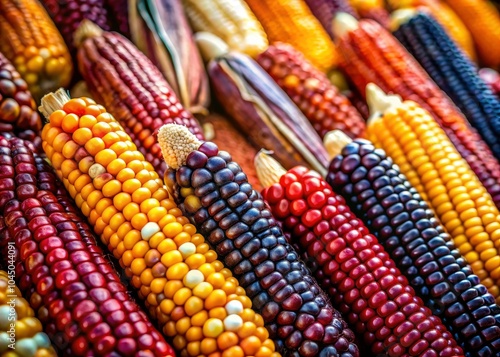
[129,0,210,114]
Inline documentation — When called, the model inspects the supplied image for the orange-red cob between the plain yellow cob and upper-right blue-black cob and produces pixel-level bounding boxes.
[336,15,500,211]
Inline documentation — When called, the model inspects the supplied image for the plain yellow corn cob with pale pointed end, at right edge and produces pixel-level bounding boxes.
[367,84,500,303]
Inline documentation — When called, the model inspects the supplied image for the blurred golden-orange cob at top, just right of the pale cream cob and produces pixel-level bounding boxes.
[246,0,337,72]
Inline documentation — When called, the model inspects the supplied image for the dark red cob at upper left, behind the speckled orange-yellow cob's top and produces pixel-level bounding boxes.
[77,22,203,175]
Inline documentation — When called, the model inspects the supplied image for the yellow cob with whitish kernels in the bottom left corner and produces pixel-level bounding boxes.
[0,270,57,357]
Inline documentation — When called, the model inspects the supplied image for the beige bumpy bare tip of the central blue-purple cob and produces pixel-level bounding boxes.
[158,124,201,170]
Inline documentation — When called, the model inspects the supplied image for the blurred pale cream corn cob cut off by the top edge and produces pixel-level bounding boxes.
[182,0,269,57]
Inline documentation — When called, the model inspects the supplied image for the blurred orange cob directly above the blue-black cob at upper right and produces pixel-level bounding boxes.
[388,0,477,61]
